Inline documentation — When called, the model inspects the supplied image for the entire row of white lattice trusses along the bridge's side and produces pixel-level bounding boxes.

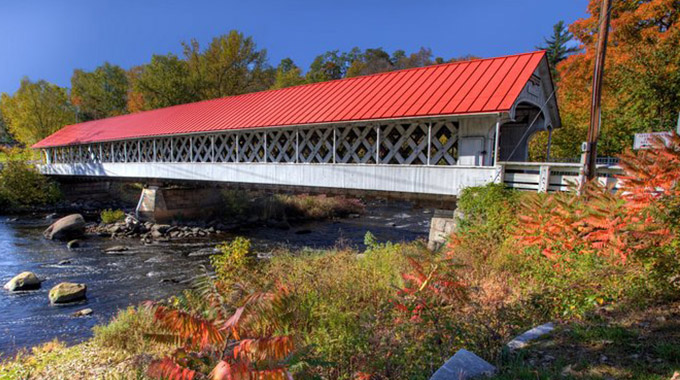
[48,121,458,165]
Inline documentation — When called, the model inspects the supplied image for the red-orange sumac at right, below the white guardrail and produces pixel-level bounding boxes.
[515,134,680,264]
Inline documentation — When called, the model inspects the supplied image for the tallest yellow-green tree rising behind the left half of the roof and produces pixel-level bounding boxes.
[182,30,275,99]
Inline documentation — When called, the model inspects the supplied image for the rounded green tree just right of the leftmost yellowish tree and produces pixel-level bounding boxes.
[71,62,128,121]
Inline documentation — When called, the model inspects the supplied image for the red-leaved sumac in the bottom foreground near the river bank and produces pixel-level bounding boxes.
[147,279,296,380]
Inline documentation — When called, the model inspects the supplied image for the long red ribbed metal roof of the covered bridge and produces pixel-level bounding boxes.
[33,51,545,148]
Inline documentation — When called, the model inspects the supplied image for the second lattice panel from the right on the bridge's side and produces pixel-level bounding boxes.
[380,123,428,165]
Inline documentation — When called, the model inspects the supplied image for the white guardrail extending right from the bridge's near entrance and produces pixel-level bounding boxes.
[499,162,623,192]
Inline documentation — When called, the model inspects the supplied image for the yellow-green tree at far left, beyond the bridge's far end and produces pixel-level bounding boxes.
[0,78,75,145]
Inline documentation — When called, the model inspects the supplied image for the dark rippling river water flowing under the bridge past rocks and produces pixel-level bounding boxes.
[0,203,431,359]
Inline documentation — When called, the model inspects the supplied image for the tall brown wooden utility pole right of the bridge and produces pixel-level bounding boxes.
[580,0,612,188]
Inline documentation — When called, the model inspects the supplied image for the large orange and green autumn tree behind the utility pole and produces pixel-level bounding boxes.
[553,0,680,157]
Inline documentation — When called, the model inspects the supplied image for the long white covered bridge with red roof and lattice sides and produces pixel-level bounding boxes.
[34,51,560,196]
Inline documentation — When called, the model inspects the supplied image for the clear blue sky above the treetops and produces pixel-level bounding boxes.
[0,0,588,93]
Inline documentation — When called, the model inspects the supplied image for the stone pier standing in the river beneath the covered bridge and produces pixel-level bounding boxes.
[136,186,221,223]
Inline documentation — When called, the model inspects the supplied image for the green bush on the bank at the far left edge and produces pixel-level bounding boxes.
[0,156,61,209]
